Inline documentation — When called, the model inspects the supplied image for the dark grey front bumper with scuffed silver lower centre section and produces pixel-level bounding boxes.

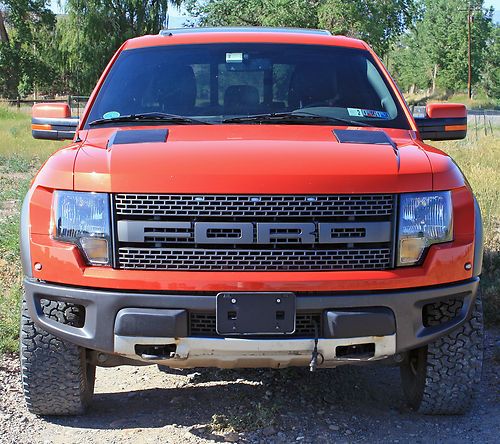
[24,277,479,367]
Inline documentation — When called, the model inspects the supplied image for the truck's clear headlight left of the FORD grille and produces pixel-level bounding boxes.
[51,191,111,265]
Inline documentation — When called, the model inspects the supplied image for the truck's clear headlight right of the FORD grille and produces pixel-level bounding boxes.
[398,191,453,265]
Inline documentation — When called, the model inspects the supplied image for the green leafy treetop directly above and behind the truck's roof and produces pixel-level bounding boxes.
[187,0,418,55]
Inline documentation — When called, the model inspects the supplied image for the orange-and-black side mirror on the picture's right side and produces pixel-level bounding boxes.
[415,103,467,140]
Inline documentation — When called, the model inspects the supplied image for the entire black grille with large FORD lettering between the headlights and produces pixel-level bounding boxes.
[113,194,395,271]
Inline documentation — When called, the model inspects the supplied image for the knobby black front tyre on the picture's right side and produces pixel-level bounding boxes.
[401,293,483,415]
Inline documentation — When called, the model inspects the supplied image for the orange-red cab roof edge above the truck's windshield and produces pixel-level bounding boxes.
[123,27,367,50]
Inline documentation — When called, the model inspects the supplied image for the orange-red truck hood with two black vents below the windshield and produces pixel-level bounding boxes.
[74,125,432,194]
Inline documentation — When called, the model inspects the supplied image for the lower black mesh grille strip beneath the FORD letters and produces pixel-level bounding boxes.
[118,247,391,271]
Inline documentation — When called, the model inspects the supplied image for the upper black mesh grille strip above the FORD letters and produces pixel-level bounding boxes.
[115,194,393,218]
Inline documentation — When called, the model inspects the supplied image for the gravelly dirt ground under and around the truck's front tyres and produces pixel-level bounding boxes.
[0,330,500,444]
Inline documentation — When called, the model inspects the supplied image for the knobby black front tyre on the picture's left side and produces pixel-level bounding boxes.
[20,297,95,415]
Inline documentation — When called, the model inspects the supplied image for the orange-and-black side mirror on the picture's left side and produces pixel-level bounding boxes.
[31,103,78,140]
